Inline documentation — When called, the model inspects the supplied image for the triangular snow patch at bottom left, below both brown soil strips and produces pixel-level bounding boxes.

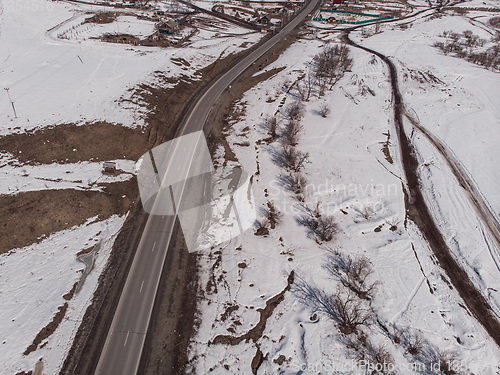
[0,216,125,374]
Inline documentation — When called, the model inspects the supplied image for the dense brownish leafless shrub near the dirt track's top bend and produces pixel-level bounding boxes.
[314,44,352,90]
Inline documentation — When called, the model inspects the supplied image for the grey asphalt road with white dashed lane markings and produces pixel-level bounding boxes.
[95,0,319,375]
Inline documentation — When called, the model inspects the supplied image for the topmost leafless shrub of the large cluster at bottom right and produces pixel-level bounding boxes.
[323,252,378,300]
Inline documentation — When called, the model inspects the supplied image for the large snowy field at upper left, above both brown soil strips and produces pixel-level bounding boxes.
[0,0,261,135]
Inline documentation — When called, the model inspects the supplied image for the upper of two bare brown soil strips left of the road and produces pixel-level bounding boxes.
[0,122,148,164]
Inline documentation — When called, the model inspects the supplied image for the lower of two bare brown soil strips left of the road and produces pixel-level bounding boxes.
[0,178,138,254]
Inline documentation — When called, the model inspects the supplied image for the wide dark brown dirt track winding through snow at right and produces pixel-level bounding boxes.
[345,21,500,346]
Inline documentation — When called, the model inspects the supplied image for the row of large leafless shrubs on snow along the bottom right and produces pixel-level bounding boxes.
[293,251,465,375]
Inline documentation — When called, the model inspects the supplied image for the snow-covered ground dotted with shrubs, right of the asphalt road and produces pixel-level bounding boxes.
[186,4,500,375]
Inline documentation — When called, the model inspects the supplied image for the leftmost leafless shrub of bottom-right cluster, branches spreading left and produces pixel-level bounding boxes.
[294,280,371,335]
